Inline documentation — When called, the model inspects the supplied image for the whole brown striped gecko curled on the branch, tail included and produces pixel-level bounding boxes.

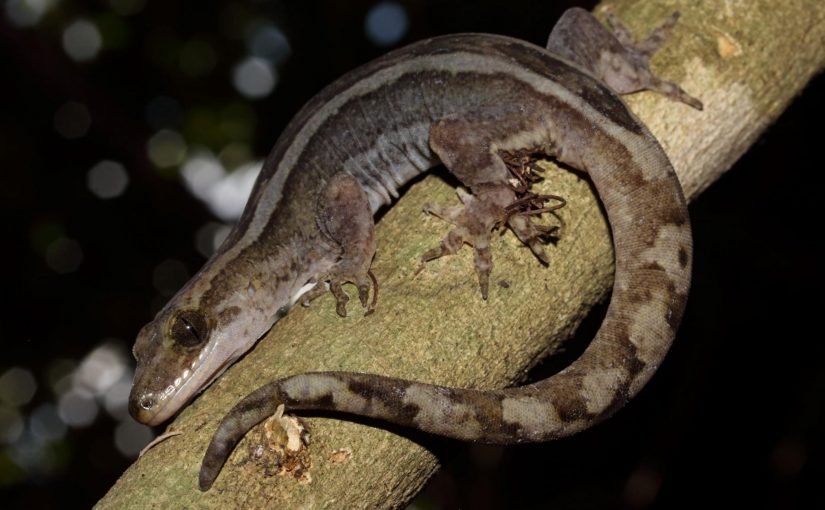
[129,8,702,490]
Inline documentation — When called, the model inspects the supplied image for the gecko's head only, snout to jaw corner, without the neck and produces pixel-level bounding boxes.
[129,303,251,425]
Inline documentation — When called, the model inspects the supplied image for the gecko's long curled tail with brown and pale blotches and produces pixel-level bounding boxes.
[199,146,691,490]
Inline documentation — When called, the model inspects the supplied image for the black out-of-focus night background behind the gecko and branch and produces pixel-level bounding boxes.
[0,0,825,508]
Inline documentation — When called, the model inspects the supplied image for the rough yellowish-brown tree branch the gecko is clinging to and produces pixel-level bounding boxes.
[98,0,825,508]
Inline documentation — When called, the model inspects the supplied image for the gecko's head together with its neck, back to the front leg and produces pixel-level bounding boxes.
[129,239,332,425]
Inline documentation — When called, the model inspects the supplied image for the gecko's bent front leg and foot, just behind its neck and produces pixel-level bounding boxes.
[303,172,378,317]
